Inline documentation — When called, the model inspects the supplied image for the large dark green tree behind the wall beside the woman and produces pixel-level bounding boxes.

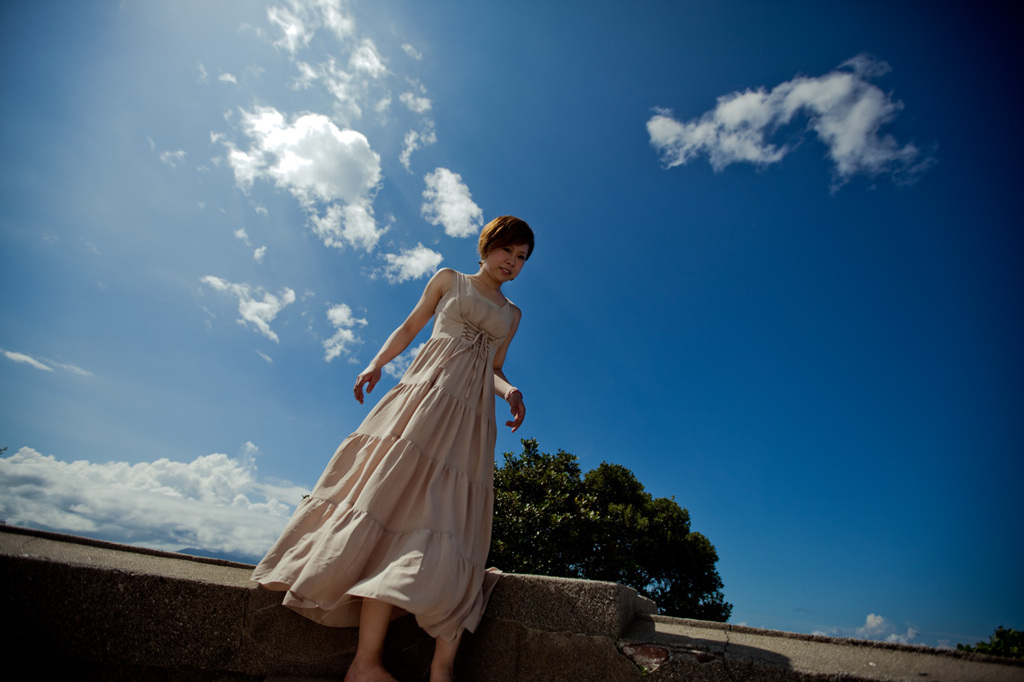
[489,439,732,622]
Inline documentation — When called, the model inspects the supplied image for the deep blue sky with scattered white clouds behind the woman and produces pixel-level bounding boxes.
[0,0,1024,645]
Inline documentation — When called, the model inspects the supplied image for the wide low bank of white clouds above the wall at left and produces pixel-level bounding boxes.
[0,443,308,557]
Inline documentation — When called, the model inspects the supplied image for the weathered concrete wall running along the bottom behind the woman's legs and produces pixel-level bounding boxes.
[0,526,1024,682]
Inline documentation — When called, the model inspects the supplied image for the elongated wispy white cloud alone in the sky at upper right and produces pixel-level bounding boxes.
[647,55,933,186]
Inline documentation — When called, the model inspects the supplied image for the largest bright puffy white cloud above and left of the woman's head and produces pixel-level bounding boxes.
[227,108,383,251]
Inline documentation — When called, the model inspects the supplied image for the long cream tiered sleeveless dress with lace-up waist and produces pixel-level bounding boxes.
[253,272,513,640]
